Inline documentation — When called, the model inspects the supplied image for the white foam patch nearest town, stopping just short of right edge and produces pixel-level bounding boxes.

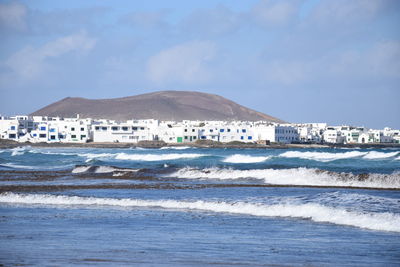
[279,151,368,162]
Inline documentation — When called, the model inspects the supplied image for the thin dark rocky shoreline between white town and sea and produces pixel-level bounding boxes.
[0,139,400,149]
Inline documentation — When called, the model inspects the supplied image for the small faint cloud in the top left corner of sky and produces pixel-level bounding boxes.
[0,3,27,30]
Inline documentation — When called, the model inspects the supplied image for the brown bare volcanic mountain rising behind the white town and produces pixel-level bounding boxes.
[30,91,282,122]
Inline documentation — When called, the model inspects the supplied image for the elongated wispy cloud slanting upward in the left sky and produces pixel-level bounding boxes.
[3,32,96,79]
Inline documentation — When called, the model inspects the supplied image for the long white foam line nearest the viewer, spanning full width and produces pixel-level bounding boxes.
[0,193,400,232]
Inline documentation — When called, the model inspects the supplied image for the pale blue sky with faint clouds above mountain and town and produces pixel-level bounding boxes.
[0,0,400,129]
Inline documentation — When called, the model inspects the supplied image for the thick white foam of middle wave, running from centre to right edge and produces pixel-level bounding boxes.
[167,167,400,188]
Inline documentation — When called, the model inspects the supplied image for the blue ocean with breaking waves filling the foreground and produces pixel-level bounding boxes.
[0,146,400,266]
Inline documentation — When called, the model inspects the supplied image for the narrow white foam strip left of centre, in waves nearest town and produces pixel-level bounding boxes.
[115,153,207,161]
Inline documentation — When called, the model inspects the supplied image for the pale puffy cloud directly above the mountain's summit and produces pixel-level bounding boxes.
[147,41,216,84]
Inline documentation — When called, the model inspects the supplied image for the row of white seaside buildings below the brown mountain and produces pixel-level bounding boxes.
[0,115,400,145]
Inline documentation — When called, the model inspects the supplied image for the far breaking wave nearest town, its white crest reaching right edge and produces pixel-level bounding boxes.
[279,151,399,162]
